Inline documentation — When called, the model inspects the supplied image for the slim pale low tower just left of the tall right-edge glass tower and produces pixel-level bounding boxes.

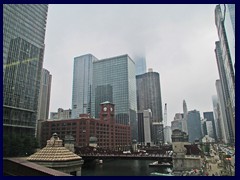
[216,80,230,143]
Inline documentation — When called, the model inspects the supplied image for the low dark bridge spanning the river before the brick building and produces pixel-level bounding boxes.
[78,153,172,162]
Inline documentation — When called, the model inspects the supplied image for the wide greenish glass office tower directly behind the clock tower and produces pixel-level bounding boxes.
[91,55,137,139]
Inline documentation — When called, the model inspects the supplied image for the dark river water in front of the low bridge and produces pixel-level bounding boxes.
[82,159,172,176]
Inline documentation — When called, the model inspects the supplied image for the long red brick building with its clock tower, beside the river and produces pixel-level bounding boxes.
[41,101,131,150]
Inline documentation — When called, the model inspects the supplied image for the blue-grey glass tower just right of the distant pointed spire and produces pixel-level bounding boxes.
[187,110,202,142]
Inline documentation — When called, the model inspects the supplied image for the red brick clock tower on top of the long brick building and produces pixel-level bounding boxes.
[100,101,114,121]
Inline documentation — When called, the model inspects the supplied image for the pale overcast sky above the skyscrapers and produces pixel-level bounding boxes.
[43,4,219,125]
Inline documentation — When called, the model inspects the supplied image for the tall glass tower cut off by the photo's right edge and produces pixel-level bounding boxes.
[215,4,235,143]
